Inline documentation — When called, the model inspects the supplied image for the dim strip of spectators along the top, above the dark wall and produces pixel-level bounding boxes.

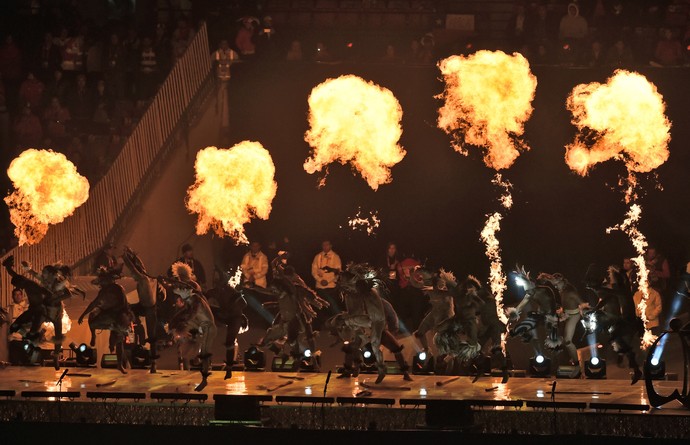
[208,0,690,67]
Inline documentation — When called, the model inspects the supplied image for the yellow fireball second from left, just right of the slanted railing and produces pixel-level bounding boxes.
[186,141,278,244]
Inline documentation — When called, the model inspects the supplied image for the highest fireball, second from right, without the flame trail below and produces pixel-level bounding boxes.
[438,51,537,170]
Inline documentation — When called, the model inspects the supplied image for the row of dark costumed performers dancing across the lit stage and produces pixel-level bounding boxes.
[2,243,684,390]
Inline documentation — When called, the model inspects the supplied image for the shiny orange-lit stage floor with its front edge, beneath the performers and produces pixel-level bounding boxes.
[0,366,690,437]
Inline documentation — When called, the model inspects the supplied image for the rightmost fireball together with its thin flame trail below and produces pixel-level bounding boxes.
[565,70,671,349]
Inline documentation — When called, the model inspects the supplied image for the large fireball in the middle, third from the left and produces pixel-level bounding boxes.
[304,75,405,190]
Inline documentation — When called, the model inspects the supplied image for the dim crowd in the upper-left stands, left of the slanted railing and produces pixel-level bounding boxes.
[0,0,202,251]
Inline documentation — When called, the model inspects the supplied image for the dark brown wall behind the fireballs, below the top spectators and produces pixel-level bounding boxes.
[220,60,690,302]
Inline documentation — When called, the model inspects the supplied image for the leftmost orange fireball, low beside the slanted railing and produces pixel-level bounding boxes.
[5,148,89,246]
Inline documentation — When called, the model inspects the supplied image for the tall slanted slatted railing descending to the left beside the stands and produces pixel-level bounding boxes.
[0,24,212,307]
